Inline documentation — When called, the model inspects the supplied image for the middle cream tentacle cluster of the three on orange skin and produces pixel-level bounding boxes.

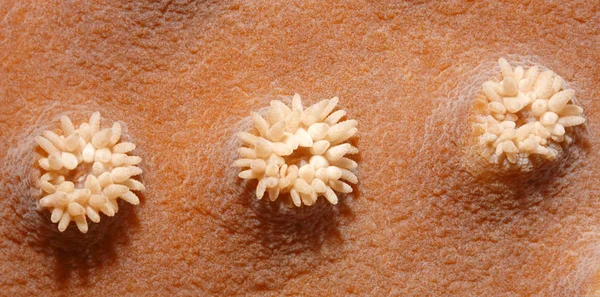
[233,94,358,207]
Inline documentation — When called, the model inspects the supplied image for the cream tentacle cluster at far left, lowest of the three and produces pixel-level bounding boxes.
[35,112,144,233]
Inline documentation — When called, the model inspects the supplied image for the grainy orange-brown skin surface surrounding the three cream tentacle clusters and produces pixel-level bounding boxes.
[0,0,600,296]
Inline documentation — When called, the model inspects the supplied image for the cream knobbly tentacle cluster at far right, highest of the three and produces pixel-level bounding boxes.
[478,58,585,163]
